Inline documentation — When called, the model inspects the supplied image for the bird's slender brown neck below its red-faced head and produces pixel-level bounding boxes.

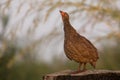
[64,20,76,38]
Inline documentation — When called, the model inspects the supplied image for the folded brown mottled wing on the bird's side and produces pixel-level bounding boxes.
[74,35,98,60]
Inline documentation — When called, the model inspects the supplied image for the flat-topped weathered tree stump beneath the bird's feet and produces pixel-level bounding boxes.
[43,70,120,80]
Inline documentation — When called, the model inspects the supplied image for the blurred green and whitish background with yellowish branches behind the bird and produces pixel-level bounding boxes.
[0,0,120,80]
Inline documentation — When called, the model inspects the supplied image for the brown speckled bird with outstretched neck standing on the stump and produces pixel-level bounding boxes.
[59,10,99,73]
